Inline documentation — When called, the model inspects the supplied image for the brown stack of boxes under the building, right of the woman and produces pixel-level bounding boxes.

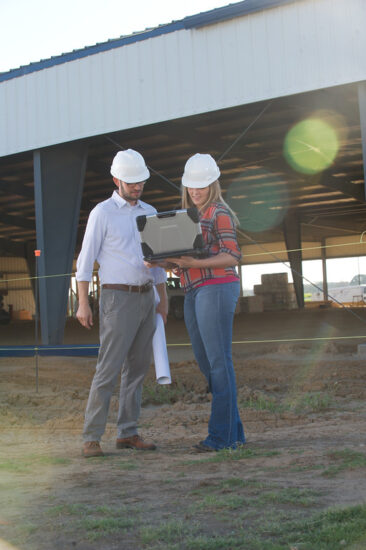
[254,273,297,311]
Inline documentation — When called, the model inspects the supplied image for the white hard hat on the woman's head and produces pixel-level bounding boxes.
[182,153,220,189]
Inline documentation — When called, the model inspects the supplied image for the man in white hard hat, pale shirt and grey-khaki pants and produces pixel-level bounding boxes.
[76,149,168,458]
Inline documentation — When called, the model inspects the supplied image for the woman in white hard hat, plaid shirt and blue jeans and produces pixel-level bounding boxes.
[168,153,245,452]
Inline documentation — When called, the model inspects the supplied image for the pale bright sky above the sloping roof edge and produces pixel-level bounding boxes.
[0,0,235,72]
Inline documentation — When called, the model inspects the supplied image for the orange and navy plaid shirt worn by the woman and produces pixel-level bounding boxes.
[179,202,241,292]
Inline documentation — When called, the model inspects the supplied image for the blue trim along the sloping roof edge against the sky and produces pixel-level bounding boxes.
[0,0,299,82]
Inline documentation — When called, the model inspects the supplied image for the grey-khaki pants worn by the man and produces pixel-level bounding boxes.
[83,289,155,441]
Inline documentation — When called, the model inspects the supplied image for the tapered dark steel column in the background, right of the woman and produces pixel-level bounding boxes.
[283,213,305,308]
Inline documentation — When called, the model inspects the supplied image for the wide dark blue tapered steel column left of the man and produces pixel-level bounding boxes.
[33,142,87,345]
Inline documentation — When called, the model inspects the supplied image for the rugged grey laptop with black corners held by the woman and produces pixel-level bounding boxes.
[136,208,205,262]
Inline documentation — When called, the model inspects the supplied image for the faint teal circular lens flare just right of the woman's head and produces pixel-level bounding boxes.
[225,169,289,232]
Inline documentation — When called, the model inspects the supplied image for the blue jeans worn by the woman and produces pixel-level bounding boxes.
[184,282,245,450]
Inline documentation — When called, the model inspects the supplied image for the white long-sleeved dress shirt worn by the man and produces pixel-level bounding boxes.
[76,191,166,286]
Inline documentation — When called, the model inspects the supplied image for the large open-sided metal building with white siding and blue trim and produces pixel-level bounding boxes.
[0,0,366,344]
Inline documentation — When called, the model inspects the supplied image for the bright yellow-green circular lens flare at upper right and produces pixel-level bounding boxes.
[284,117,339,174]
